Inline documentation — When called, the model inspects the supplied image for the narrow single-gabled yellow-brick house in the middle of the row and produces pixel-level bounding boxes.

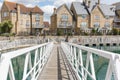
[50,4,73,35]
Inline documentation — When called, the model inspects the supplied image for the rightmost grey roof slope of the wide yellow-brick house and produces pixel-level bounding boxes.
[100,4,115,16]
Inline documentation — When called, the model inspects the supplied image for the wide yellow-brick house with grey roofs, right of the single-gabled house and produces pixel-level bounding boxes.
[71,0,115,33]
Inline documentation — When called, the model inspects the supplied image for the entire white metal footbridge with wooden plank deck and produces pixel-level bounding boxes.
[0,42,120,80]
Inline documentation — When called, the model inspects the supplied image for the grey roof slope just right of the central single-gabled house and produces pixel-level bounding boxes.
[72,2,88,15]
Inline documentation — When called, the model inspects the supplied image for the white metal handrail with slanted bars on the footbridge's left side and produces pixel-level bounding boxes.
[0,42,54,80]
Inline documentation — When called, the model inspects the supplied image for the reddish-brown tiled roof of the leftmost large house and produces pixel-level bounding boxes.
[5,1,43,13]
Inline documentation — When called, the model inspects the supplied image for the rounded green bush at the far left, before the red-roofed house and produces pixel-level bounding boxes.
[0,20,13,34]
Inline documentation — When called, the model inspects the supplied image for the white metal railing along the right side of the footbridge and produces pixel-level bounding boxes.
[61,42,120,80]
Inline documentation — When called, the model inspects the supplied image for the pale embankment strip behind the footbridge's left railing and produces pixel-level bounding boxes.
[0,39,49,50]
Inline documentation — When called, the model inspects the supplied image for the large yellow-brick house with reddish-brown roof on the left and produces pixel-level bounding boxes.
[1,1,44,35]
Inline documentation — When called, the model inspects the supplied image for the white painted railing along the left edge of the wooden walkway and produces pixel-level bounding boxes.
[0,42,53,80]
